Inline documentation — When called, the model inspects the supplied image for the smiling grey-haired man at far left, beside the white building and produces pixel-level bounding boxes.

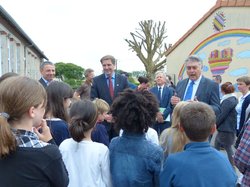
[39,61,56,88]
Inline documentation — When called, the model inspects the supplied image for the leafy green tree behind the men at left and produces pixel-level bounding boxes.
[55,62,84,89]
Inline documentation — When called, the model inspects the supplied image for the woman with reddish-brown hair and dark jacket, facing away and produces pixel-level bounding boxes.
[214,82,238,165]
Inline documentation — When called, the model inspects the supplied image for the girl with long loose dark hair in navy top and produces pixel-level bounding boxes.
[45,81,73,146]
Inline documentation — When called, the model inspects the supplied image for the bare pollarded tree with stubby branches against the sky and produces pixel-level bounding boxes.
[125,20,167,82]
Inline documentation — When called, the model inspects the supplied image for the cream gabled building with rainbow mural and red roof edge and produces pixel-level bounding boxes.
[166,0,250,83]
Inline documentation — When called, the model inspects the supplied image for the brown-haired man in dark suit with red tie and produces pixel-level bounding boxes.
[91,55,128,139]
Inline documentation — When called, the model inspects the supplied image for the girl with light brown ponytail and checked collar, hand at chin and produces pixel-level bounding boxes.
[0,76,69,187]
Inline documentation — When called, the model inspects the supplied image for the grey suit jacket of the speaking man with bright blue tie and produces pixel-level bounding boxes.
[176,76,220,116]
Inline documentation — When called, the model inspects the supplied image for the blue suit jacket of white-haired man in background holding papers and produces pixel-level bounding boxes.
[150,86,174,119]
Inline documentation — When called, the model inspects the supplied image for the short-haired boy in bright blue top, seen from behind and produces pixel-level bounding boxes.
[160,102,237,187]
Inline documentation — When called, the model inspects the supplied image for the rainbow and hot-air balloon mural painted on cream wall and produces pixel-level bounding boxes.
[178,29,250,80]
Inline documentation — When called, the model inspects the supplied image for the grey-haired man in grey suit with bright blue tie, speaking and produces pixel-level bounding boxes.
[171,55,220,116]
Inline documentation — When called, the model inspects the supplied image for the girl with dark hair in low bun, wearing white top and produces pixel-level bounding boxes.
[59,100,111,187]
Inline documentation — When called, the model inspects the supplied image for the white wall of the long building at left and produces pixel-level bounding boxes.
[0,23,42,79]
